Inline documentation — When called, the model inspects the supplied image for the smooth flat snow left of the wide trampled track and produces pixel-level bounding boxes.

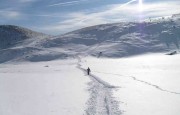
[0,60,90,115]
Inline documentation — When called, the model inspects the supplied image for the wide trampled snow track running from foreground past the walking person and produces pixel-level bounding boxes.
[77,56,121,115]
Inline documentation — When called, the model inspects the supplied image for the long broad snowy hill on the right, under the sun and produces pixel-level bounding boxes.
[48,20,180,57]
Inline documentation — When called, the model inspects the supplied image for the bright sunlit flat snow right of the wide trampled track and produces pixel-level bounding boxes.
[83,54,180,115]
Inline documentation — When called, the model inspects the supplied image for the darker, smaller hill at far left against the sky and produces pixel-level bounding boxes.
[0,25,47,49]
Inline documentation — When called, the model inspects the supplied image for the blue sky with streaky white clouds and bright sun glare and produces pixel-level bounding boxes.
[0,0,180,35]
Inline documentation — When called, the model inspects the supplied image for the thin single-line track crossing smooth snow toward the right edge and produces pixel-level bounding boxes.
[94,71,180,95]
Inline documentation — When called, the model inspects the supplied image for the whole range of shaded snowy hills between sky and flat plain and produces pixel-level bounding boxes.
[0,19,180,63]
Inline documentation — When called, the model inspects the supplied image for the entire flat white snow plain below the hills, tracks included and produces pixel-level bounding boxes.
[0,53,180,115]
